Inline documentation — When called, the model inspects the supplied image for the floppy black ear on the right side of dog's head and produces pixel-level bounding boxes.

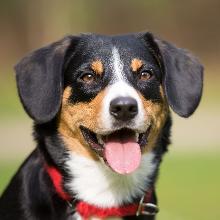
[141,33,203,117]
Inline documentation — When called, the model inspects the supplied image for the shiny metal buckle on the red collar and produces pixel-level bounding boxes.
[136,196,159,216]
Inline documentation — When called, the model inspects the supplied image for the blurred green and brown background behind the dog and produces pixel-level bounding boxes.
[0,0,220,220]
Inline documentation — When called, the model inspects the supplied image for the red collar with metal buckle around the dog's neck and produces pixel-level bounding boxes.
[45,165,158,220]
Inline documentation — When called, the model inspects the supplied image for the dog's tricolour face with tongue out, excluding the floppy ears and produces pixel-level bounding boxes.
[59,35,168,173]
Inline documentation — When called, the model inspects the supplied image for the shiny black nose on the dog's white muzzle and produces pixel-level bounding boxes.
[110,97,138,121]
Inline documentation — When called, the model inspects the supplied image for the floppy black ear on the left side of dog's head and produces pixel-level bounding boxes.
[15,37,73,123]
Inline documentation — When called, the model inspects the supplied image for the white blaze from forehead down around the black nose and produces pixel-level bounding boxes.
[101,47,148,131]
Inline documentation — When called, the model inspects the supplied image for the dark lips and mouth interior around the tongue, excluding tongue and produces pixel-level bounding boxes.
[80,126,150,157]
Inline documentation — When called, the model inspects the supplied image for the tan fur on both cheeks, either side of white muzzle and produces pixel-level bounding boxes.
[58,84,169,160]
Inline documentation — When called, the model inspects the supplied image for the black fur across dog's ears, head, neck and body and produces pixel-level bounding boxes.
[0,33,203,220]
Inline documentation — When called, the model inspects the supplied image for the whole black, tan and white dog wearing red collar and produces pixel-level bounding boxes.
[0,32,203,220]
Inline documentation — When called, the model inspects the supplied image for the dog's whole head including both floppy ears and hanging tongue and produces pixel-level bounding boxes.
[15,33,203,173]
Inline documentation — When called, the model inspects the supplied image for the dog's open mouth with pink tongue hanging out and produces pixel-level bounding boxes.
[80,126,150,174]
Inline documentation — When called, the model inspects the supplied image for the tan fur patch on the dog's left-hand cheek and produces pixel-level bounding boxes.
[58,87,104,160]
